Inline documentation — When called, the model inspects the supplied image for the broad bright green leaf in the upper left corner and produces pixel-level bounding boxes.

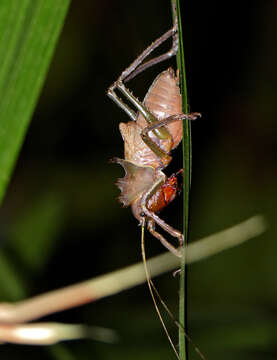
[0,0,70,205]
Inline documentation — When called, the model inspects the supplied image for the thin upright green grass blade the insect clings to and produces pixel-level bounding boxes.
[171,0,191,360]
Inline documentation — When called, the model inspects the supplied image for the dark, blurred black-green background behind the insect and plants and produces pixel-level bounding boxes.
[0,0,277,360]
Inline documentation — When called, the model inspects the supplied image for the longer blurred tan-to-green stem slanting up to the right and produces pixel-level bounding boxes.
[0,215,267,324]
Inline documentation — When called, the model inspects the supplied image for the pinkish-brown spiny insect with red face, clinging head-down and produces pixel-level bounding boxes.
[107,24,200,256]
